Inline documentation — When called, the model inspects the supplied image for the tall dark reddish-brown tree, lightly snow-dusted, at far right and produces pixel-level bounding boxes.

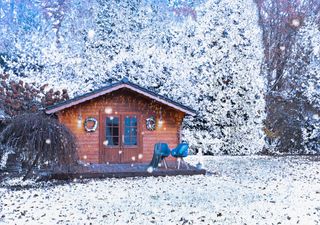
[255,0,320,153]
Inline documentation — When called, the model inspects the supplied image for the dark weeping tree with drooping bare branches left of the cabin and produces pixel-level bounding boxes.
[0,113,77,180]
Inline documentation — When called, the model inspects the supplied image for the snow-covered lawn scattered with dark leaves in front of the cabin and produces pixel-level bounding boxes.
[0,156,320,225]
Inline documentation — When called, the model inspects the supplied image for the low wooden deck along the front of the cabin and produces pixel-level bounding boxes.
[40,163,206,180]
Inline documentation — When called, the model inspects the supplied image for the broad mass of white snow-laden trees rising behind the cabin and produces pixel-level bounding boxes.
[0,0,264,154]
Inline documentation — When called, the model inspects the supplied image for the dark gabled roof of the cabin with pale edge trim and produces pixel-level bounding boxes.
[45,78,196,116]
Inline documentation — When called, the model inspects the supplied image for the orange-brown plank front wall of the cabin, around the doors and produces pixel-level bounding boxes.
[57,89,185,163]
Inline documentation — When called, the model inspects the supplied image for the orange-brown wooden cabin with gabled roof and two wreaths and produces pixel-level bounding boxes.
[45,79,196,164]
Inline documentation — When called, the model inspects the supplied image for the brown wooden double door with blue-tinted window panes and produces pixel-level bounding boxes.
[100,113,140,163]
